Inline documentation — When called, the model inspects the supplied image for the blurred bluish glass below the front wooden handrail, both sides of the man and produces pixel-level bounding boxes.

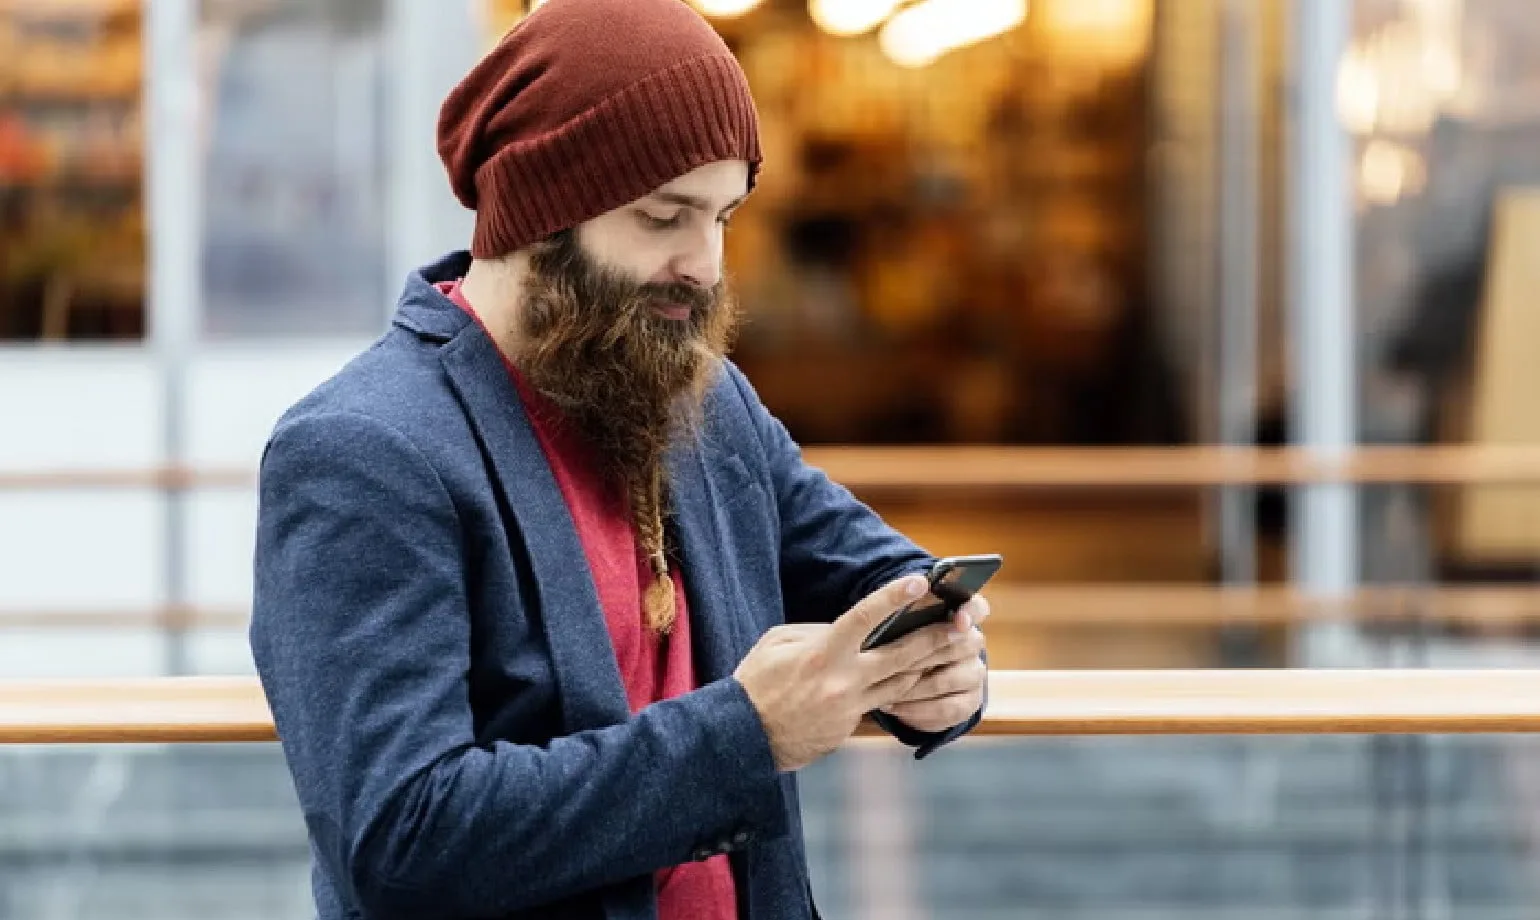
[0,735,1540,920]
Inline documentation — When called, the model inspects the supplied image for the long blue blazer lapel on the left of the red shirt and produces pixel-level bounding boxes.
[439,324,630,732]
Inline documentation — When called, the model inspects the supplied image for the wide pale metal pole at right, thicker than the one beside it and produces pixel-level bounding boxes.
[1289,0,1360,666]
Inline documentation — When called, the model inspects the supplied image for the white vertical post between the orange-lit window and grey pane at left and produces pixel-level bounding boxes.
[145,0,203,673]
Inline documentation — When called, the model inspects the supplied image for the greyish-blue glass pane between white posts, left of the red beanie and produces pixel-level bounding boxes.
[200,0,394,339]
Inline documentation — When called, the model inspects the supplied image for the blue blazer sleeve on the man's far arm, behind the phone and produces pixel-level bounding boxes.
[725,364,989,760]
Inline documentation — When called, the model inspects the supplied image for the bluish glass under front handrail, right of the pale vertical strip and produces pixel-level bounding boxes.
[899,737,1537,920]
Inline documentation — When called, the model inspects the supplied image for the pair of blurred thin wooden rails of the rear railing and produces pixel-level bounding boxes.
[9,445,1540,630]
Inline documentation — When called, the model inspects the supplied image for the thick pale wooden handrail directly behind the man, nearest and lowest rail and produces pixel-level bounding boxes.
[9,669,1540,744]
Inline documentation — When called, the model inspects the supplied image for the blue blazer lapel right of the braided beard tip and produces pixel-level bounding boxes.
[670,442,748,684]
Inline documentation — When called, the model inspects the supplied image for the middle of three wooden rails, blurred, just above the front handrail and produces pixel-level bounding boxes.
[15,583,1540,630]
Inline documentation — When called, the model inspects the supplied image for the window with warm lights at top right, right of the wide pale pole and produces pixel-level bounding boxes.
[1340,0,1540,441]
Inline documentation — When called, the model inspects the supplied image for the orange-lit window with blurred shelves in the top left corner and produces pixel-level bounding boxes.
[0,0,145,341]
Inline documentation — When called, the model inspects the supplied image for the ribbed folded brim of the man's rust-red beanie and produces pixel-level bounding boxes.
[471,54,759,259]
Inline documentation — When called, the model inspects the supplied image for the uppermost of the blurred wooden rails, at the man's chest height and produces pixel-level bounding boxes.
[15,445,1540,492]
